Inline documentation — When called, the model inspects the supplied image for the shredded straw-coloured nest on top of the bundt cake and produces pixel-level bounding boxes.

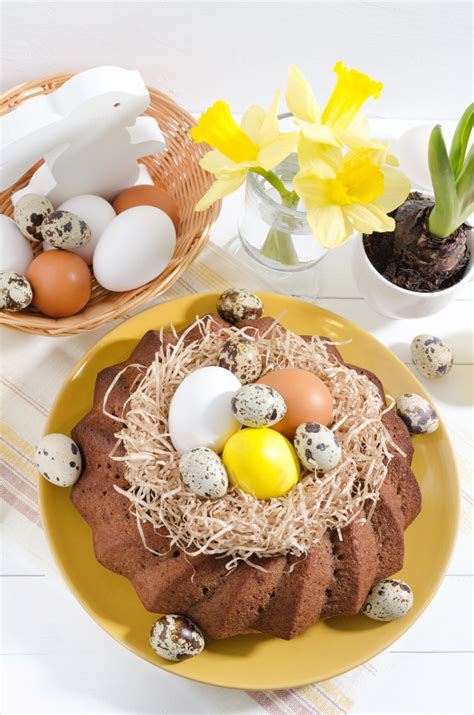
[104,317,396,569]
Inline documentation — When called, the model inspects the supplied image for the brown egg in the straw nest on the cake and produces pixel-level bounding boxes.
[257,367,333,439]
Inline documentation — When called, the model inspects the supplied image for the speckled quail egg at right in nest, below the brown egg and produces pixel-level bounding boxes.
[294,422,341,472]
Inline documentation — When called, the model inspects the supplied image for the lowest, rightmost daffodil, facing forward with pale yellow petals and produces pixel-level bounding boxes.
[293,144,410,248]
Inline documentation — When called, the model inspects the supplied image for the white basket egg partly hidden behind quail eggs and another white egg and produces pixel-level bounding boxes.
[43,194,117,265]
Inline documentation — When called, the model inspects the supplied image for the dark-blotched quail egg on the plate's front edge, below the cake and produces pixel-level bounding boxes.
[150,614,206,660]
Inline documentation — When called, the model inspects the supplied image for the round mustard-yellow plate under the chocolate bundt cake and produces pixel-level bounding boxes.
[40,294,459,689]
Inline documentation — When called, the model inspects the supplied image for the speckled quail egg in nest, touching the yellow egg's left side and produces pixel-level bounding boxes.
[179,447,229,497]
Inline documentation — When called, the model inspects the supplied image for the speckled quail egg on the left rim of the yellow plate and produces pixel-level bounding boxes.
[35,433,82,487]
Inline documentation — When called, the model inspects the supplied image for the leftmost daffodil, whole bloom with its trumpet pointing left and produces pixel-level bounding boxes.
[190,92,299,211]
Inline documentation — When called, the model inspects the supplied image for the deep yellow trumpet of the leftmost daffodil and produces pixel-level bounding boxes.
[189,100,258,164]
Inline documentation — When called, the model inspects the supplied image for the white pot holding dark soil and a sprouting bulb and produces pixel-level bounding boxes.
[353,231,473,319]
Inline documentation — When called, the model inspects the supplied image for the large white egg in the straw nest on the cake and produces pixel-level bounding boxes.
[168,370,241,453]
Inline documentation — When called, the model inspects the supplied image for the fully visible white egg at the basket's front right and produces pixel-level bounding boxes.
[93,206,176,291]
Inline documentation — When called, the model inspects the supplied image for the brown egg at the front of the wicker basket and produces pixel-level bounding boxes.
[26,250,91,318]
